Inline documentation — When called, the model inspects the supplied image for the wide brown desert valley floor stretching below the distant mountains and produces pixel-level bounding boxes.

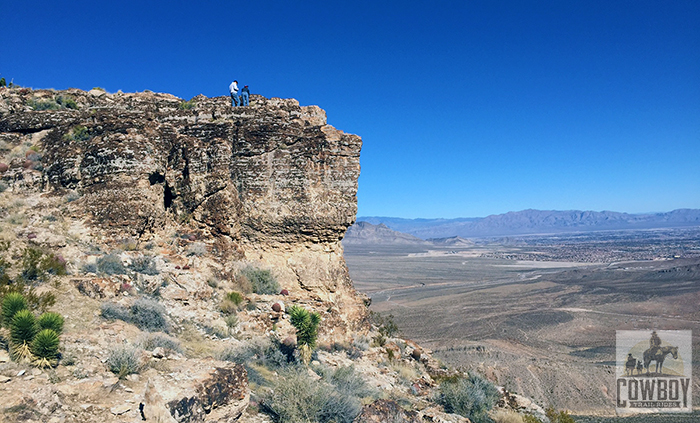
[344,223,700,421]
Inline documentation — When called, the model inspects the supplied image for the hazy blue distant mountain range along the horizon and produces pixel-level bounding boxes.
[356,209,700,240]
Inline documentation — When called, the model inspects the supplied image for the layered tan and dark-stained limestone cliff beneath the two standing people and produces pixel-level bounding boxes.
[0,89,362,312]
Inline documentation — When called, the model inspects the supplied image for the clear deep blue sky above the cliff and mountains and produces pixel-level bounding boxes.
[0,0,700,218]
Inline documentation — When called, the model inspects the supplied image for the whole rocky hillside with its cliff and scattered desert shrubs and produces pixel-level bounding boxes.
[0,87,542,423]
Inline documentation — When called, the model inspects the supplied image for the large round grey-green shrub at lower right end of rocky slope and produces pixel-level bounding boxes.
[435,373,500,423]
